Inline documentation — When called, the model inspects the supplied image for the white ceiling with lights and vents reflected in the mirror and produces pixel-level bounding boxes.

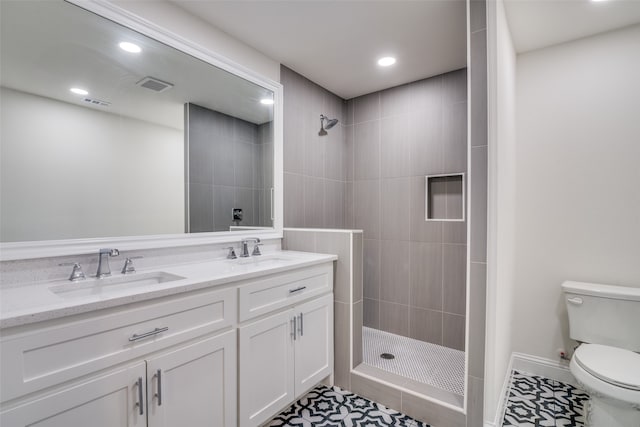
[0,0,273,129]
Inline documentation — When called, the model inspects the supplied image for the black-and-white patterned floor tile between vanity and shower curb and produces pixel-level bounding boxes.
[266,385,429,427]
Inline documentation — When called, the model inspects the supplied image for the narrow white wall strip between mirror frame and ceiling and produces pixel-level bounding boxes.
[112,0,280,82]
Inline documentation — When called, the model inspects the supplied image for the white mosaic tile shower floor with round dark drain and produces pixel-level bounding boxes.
[362,327,465,396]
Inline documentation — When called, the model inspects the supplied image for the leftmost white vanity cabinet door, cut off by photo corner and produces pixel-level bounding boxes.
[0,362,147,427]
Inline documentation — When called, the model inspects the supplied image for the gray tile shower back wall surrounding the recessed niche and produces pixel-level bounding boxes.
[344,69,467,350]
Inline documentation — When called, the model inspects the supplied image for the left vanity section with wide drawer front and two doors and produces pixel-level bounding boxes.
[0,288,237,427]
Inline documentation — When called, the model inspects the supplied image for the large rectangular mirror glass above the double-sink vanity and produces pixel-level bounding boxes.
[0,0,281,249]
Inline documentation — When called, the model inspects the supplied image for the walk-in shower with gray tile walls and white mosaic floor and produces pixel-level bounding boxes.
[282,63,467,405]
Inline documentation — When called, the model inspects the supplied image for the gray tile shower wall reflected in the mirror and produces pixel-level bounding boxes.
[185,104,273,233]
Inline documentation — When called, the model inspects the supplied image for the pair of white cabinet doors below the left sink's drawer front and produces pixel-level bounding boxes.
[0,331,236,427]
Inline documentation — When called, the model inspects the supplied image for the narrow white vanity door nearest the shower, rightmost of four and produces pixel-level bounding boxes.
[294,295,336,396]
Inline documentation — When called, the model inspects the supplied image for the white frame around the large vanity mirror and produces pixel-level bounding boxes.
[0,0,284,261]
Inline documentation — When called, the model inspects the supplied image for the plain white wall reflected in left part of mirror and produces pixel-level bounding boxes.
[0,88,184,241]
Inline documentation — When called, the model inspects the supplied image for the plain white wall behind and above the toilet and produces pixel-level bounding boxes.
[512,25,640,359]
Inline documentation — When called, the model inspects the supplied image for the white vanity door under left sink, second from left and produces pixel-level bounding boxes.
[147,330,237,427]
